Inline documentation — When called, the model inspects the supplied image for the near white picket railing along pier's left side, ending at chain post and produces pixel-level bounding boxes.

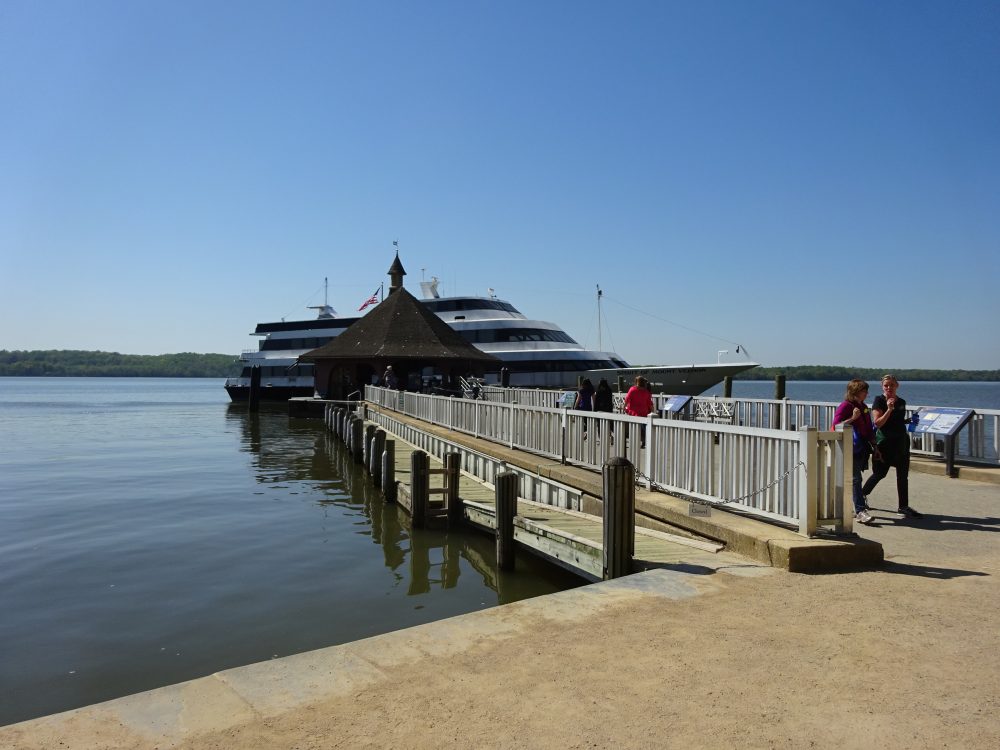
[365,386,853,535]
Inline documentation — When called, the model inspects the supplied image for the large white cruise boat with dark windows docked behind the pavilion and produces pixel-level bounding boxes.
[226,278,757,401]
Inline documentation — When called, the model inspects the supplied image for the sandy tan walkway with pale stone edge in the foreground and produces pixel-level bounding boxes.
[0,473,1000,749]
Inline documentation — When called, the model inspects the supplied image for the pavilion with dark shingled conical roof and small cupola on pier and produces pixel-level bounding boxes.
[299,252,500,399]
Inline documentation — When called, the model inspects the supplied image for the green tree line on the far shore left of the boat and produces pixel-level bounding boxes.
[0,349,236,378]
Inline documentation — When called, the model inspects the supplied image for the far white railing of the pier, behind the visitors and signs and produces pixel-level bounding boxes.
[482,386,1000,466]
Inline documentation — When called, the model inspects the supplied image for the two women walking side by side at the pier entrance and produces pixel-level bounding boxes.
[833,375,923,524]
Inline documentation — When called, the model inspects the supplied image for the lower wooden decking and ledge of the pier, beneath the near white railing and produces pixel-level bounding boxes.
[331,405,882,580]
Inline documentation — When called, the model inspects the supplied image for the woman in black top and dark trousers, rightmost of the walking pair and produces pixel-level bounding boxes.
[861,375,923,518]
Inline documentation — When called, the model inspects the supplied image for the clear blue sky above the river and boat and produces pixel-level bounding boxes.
[0,0,1000,369]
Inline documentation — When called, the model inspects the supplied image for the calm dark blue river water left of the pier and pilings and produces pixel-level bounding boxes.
[0,378,581,724]
